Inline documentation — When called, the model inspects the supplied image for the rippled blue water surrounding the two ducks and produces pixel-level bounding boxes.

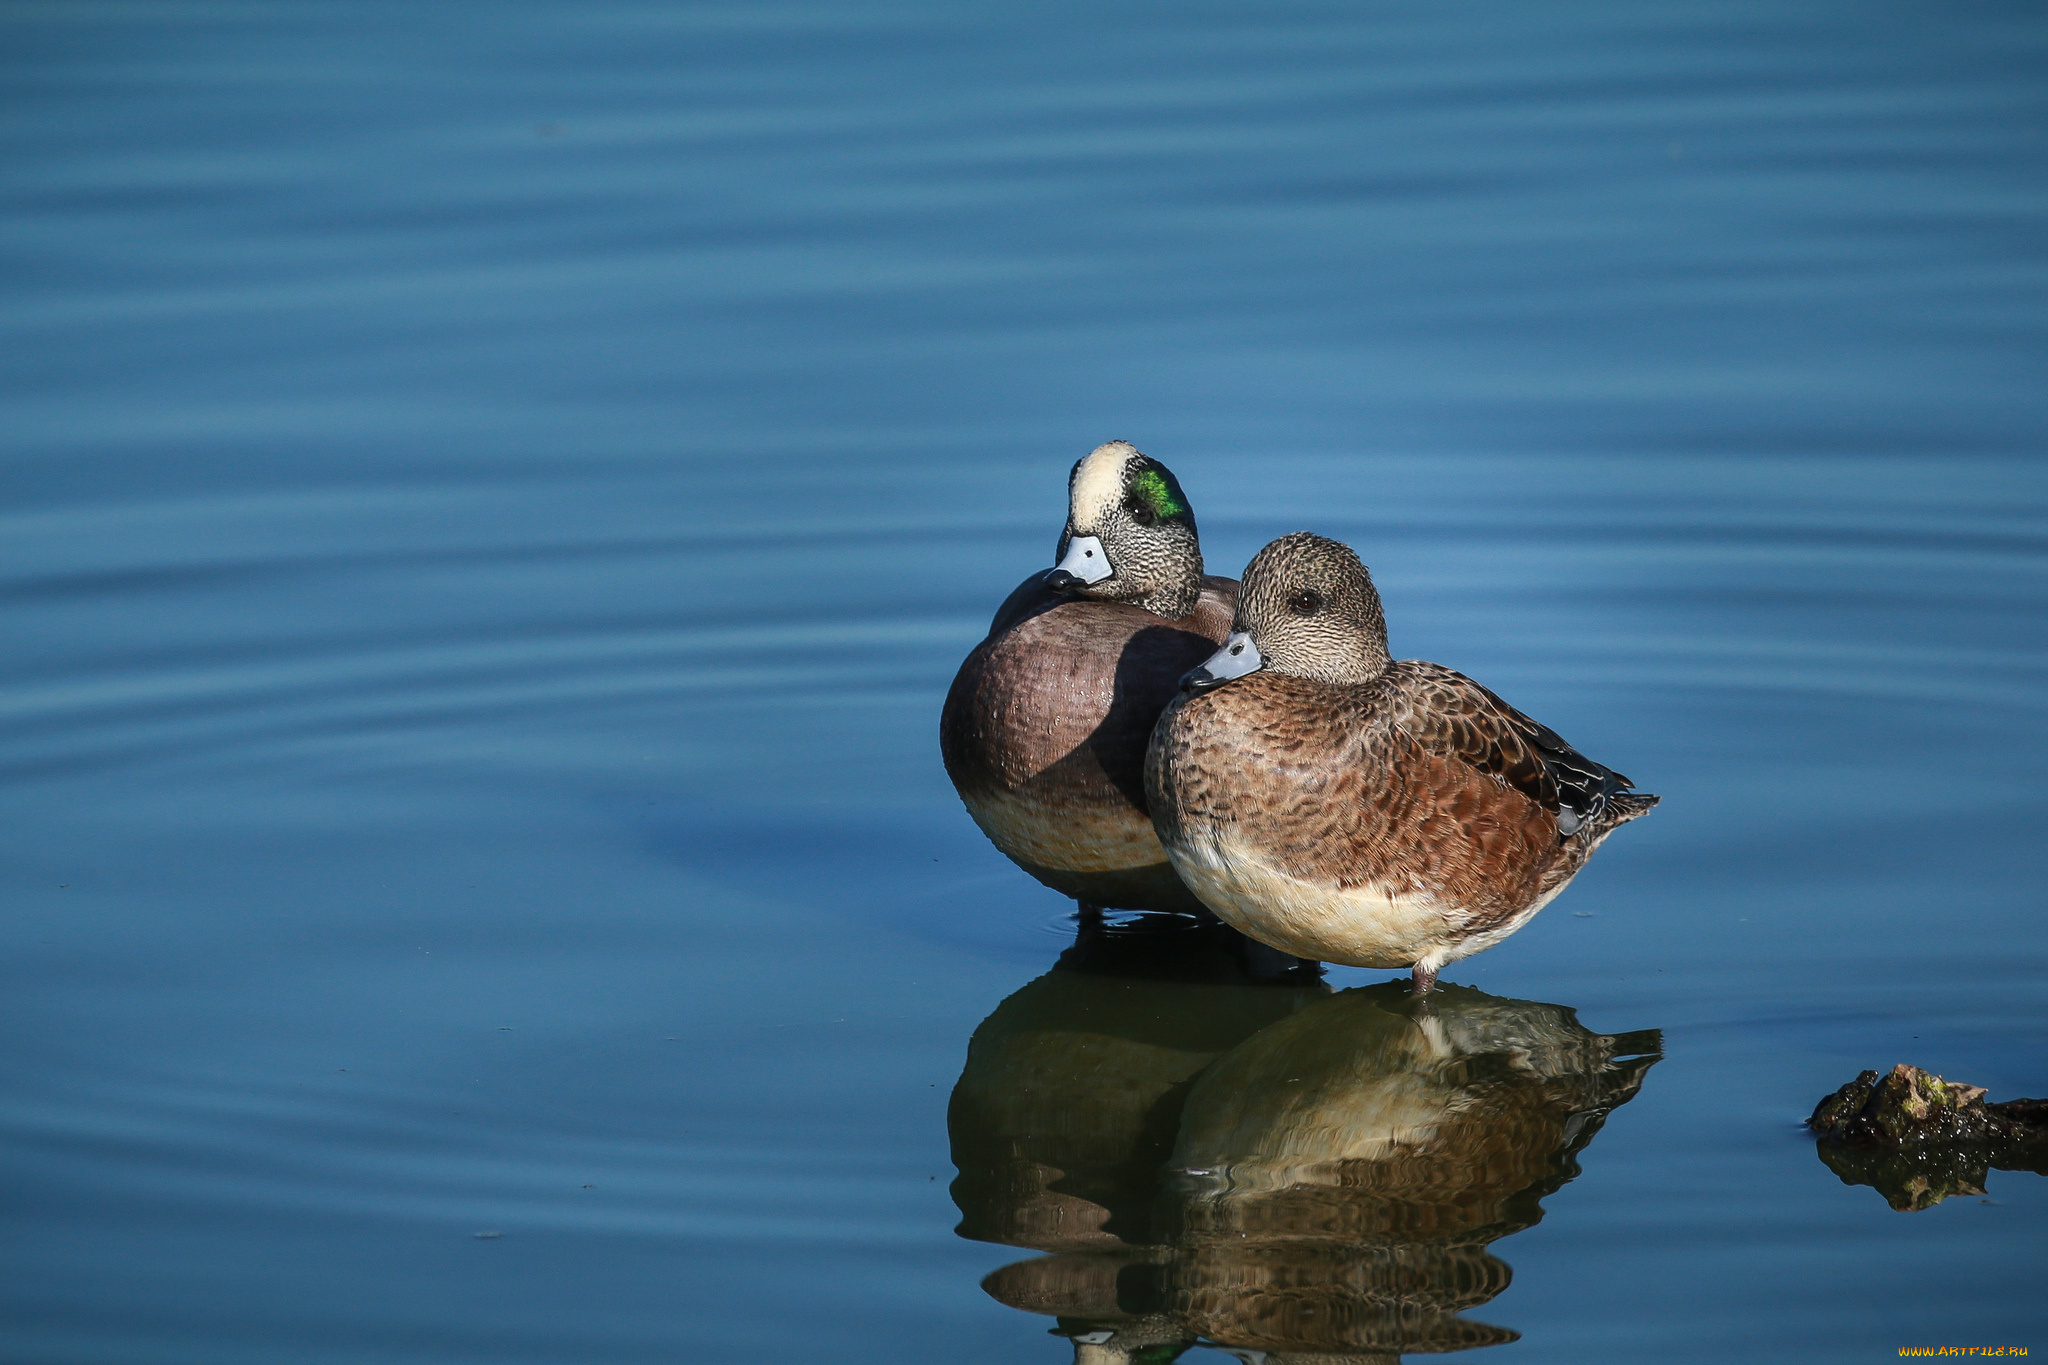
[0,0,2048,1365]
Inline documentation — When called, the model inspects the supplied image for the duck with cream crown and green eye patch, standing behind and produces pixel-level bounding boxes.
[938,440,1237,917]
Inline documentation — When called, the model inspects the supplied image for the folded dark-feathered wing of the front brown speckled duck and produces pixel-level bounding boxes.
[1389,663,1655,837]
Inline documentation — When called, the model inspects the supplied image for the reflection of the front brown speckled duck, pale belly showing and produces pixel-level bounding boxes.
[1167,982,1659,1361]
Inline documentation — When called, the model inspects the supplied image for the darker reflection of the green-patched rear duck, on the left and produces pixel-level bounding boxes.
[946,915,1329,1365]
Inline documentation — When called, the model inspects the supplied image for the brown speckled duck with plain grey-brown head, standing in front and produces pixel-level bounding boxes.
[1145,532,1657,997]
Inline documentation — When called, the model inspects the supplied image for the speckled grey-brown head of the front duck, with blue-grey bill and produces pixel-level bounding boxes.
[1182,530,1391,692]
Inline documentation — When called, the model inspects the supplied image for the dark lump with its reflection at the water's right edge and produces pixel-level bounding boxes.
[1806,1062,2048,1212]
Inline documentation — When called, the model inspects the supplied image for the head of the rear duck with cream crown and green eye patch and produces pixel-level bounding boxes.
[1047,440,1202,620]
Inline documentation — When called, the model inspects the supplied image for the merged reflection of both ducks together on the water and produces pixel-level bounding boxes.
[952,957,1659,1365]
